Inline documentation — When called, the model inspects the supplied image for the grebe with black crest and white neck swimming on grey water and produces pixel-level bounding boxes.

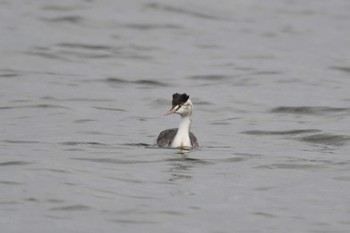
[157,93,199,148]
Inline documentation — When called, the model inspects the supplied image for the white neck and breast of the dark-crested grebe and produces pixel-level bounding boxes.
[171,115,192,148]
